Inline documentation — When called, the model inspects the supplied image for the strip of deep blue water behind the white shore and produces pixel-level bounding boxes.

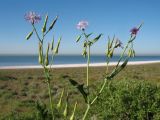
[0,55,160,66]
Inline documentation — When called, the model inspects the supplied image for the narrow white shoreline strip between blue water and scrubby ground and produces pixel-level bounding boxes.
[0,60,160,70]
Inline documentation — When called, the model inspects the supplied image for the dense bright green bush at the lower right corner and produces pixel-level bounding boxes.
[92,80,160,120]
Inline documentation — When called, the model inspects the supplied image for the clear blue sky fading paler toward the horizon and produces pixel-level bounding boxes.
[0,0,160,55]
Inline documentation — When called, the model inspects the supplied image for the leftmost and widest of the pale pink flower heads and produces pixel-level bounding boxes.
[24,11,41,24]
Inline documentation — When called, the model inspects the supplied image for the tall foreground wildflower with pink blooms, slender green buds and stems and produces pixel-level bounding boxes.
[25,12,142,120]
